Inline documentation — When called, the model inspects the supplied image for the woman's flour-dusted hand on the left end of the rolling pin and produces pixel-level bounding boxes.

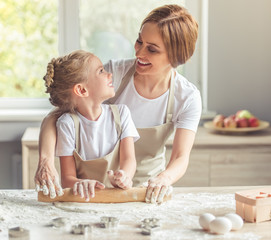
[34,161,63,198]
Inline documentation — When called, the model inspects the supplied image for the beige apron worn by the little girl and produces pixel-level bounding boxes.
[71,105,121,187]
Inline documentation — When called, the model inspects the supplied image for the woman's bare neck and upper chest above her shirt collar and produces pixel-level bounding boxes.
[134,70,172,99]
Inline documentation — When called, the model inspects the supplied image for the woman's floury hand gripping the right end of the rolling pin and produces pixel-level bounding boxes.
[145,175,173,204]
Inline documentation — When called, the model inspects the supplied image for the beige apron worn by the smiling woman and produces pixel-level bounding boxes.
[109,65,175,186]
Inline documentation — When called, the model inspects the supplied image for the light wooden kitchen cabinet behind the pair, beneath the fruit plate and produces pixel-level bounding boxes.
[22,127,271,189]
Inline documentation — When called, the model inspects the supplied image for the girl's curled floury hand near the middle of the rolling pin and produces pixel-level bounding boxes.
[107,170,133,189]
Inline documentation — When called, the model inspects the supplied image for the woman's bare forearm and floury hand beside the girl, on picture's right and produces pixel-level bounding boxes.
[146,128,196,203]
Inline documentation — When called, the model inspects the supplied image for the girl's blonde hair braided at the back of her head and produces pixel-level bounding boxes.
[43,50,94,113]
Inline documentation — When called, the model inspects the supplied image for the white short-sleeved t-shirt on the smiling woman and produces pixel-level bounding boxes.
[104,59,202,132]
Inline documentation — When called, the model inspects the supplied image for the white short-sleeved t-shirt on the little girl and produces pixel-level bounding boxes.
[56,104,139,160]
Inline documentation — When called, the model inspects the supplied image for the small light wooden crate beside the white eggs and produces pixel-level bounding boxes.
[235,187,271,222]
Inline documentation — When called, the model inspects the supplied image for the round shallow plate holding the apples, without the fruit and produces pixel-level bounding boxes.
[203,121,269,133]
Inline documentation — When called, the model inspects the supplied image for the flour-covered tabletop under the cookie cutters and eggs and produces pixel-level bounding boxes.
[0,186,271,240]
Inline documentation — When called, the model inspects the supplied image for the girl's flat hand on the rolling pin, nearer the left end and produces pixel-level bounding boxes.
[73,179,105,202]
